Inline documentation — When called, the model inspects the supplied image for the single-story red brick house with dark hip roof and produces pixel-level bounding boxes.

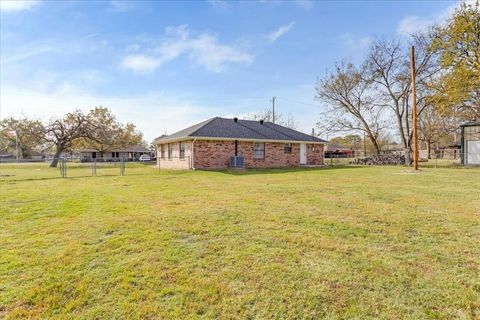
[155,117,326,169]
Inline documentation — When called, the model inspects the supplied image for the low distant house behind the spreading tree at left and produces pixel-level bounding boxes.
[76,146,152,162]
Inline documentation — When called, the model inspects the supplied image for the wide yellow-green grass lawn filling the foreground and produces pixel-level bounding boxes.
[0,165,480,319]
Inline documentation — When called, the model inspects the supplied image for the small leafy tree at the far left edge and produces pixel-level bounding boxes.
[0,117,45,158]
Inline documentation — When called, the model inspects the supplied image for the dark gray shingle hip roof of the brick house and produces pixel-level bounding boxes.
[157,117,326,142]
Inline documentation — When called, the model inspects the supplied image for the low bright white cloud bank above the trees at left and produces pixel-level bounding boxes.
[0,83,221,141]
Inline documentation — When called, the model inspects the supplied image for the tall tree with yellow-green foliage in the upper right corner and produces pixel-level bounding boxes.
[430,1,480,120]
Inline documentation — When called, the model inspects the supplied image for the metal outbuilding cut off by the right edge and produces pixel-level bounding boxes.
[460,121,480,165]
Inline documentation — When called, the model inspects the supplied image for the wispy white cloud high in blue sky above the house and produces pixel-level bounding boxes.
[121,25,253,73]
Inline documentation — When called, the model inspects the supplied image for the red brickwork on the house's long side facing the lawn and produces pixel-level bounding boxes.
[194,140,323,169]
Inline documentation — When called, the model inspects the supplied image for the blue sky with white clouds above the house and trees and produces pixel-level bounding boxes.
[0,0,457,141]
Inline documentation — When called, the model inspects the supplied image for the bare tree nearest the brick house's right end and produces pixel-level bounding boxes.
[315,63,386,154]
